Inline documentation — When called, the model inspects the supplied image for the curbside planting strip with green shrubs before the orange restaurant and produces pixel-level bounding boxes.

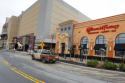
[60,59,125,72]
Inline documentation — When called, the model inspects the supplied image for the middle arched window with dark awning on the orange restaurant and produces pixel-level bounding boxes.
[94,35,106,56]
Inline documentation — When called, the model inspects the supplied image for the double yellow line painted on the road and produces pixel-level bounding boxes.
[3,60,45,83]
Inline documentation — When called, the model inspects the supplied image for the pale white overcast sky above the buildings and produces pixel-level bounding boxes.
[0,0,125,31]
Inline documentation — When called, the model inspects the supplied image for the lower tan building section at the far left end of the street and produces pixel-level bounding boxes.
[0,16,19,48]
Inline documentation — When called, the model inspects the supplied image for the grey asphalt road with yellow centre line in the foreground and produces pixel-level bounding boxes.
[0,51,125,83]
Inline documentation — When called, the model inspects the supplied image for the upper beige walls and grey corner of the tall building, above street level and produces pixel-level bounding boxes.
[18,0,90,42]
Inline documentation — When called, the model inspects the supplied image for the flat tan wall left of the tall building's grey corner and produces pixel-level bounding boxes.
[18,2,40,36]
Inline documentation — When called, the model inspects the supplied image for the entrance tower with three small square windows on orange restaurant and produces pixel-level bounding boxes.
[55,20,77,55]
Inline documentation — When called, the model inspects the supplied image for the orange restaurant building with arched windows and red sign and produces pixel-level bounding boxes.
[56,14,125,58]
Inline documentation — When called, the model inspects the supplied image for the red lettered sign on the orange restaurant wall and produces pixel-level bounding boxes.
[86,24,119,34]
